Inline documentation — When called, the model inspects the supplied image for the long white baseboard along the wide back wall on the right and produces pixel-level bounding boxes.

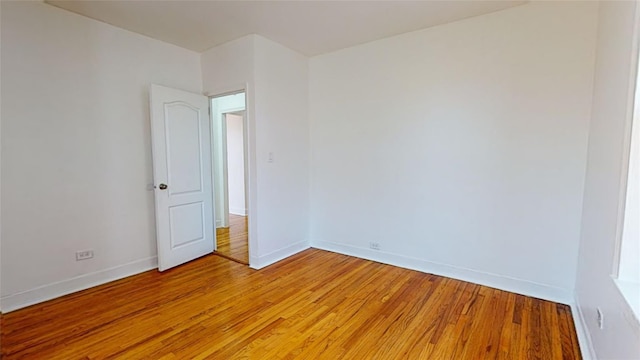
[311,241,573,305]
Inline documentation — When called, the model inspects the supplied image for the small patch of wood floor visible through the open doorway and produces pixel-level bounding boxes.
[216,214,249,265]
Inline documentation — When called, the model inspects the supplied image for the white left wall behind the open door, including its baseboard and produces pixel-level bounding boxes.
[1,2,202,311]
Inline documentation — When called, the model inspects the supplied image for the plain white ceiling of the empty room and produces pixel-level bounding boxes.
[46,0,526,56]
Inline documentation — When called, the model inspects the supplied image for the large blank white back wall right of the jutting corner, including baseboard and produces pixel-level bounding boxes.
[310,2,597,302]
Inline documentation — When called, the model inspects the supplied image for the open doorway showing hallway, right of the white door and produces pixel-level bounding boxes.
[211,92,249,265]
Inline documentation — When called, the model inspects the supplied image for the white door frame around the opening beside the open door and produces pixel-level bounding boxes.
[205,83,258,267]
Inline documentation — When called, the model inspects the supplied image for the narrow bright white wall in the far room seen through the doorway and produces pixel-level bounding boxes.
[226,114,247,216]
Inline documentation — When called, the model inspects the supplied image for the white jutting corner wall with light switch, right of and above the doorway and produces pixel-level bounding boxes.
[202,35,309,268]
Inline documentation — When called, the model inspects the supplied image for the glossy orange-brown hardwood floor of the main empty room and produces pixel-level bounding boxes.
[1,249,580,360]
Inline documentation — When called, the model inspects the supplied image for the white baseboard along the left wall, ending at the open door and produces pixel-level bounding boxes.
[0,256,158,314]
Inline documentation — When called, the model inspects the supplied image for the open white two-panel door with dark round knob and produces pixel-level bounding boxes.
[150,85,215,271]
